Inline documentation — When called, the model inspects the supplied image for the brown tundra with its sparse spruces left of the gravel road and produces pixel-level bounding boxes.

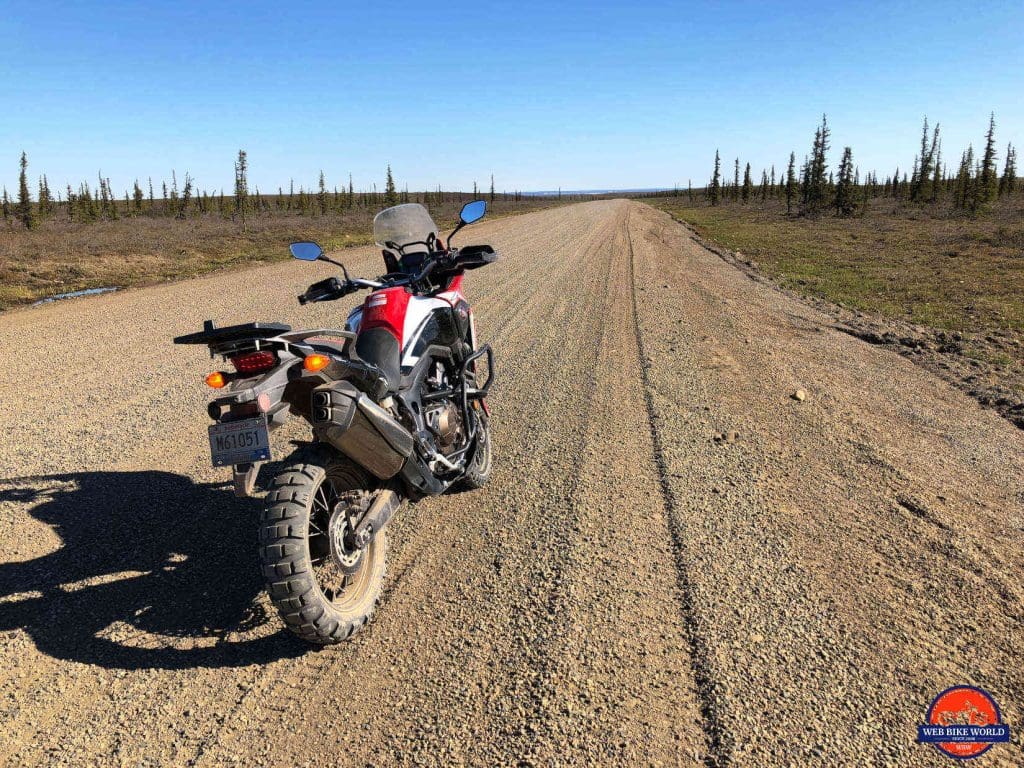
[0,151,579,309]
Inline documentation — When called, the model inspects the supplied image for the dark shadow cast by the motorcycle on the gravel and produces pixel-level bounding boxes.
[0,471,309,670]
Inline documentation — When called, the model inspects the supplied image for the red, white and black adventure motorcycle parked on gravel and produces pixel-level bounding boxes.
[174,200,498,645]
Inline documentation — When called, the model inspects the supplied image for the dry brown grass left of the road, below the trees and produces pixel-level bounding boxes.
[0,198,555,309]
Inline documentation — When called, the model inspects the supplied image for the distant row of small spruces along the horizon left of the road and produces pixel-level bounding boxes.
[0,150,525,229]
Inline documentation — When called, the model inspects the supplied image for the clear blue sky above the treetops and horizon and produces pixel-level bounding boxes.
[0,0,1024,194]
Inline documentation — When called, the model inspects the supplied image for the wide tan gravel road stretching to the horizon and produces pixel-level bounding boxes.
[0,201,1024,766]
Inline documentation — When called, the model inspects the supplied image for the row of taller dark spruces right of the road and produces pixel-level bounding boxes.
[696,114,1017,216]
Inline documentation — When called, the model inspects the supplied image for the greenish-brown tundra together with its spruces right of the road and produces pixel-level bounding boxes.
[648,116,1024,334]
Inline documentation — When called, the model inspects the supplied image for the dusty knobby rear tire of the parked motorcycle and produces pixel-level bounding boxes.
[259,455,387,645]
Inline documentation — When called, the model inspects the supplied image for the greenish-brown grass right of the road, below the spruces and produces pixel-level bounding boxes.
[647,195,1024,334]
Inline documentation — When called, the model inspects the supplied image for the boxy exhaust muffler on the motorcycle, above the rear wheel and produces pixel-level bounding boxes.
[310,381,413,480]
